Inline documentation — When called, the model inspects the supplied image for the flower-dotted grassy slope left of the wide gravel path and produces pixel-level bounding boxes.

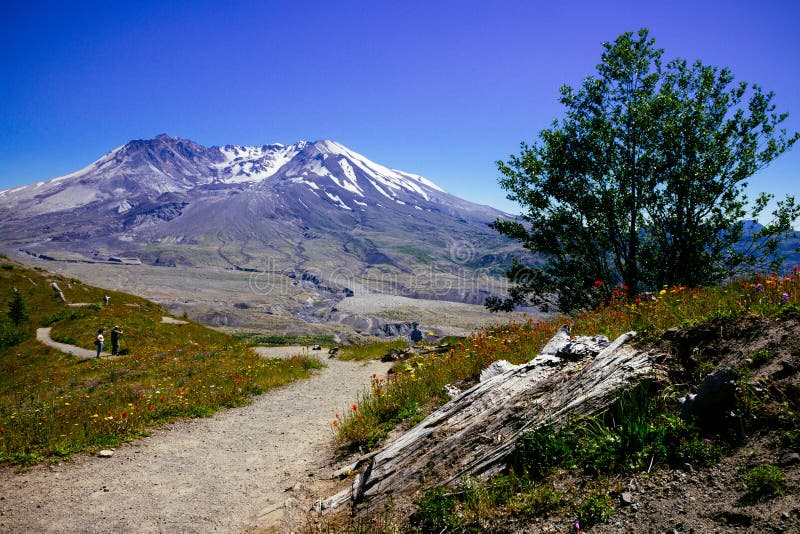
[0,261,319,464]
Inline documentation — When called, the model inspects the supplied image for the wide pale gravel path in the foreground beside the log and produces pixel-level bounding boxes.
[0,358,389,532]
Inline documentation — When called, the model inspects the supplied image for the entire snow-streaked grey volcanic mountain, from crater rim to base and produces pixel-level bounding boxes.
[0,135,510,304]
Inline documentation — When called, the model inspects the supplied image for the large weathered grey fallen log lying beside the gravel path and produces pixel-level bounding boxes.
[320,329,655,508]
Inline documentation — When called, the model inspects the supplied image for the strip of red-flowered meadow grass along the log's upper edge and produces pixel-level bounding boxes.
[333,268,800,449]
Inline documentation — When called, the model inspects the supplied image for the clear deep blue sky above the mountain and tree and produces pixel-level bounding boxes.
[0,0,800,211]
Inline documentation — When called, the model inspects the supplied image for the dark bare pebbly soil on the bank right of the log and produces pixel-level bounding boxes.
[494,317,800,533]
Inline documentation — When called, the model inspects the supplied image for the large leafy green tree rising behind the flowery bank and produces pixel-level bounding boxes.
[486,30,800,311]
